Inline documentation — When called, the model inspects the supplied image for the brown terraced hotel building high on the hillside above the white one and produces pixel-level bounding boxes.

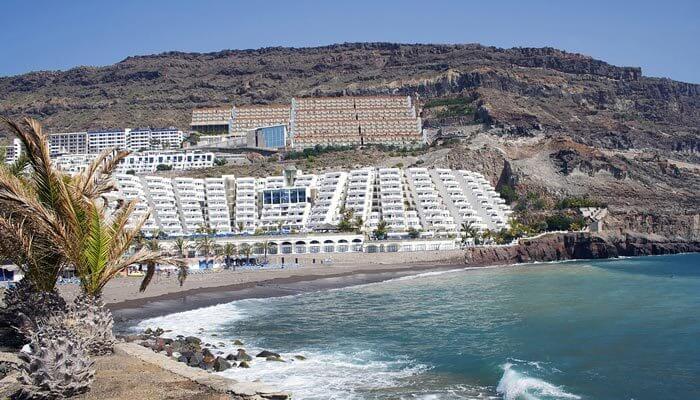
[191,95,423,148]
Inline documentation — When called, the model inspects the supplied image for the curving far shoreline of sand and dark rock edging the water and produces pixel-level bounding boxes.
[104,233,700,331]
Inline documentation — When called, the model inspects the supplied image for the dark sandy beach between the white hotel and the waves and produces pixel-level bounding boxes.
[60,255,476,329]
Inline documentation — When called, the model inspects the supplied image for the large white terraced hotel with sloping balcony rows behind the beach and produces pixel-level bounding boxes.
[116,167,512,245]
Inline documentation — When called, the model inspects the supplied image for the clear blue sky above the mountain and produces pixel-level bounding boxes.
[0,0,700,83]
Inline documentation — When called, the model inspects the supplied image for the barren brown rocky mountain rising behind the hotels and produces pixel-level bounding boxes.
[0,43,700,237]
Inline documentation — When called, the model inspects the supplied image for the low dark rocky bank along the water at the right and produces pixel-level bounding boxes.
[465,232,700,265]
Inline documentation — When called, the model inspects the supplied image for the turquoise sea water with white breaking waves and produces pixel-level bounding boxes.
[141,255,700,400]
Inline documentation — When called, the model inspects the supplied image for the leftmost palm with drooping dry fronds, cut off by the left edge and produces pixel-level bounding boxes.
[0,117,89,334]
